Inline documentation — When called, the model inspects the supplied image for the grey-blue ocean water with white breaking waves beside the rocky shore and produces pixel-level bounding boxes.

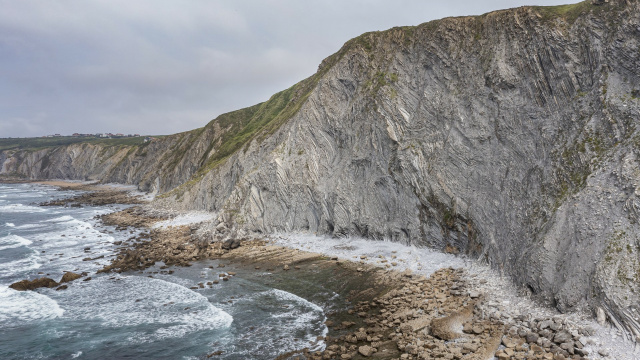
[0,184,328,359]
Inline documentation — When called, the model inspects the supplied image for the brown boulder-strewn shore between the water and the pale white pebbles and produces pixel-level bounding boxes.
[96,207,606,360]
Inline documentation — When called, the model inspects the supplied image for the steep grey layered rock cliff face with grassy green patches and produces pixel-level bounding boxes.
[0,0,640,336]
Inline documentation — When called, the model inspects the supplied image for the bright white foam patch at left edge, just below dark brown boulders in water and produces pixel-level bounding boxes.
[0,286,64,326]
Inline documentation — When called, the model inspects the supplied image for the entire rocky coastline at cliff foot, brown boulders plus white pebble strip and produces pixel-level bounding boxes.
[7,181,633,360]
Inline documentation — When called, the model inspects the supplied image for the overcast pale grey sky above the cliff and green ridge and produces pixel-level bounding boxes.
[0,0,576,138]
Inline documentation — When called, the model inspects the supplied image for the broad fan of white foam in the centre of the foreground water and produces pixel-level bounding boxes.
[60,276,233,343]
